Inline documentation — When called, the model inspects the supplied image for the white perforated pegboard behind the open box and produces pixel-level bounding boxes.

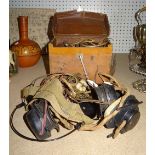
[9,0,146,53]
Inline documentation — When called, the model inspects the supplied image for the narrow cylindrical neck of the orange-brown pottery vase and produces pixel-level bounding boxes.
[18,16,28,40]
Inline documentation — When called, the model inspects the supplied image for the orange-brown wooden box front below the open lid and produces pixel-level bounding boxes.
[48,43,112,80]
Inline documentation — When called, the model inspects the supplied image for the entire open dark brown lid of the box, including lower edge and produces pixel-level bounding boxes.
[52,10,110,46]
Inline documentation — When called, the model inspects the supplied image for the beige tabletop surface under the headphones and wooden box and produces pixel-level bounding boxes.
[10,54,146,155]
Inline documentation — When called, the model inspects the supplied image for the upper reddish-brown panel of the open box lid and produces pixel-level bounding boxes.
[52,10,110,37]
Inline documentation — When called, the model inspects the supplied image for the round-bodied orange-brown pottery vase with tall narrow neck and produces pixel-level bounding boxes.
[10,16,41,67]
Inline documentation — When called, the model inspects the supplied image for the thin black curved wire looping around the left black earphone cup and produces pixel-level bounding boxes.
[10,102,78,142]
